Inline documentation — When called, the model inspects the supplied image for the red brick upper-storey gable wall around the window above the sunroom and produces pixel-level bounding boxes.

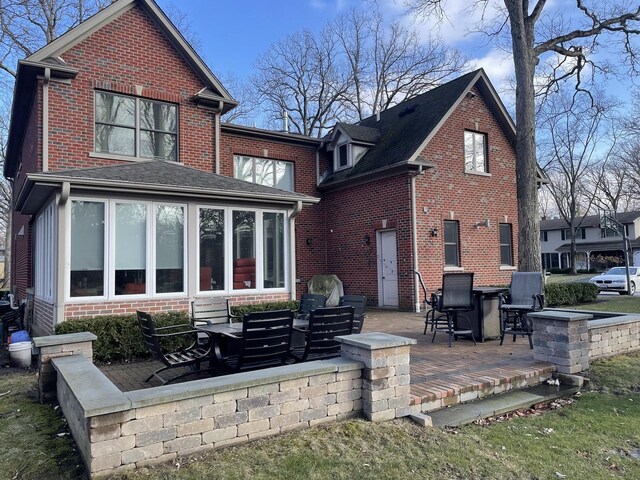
[49,7,214,171]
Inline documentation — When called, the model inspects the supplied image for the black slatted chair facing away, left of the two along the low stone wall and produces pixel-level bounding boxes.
[216,310,293,372]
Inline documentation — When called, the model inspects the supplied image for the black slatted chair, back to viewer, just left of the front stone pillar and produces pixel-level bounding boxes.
[291,306,355,362]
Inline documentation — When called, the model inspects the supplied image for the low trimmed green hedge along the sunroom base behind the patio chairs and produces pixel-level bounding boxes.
[56,301,298,362]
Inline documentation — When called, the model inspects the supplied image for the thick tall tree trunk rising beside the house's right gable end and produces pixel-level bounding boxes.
[505,0,542,272]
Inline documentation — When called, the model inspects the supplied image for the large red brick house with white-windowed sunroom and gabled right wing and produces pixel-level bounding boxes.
[4,0,518,333]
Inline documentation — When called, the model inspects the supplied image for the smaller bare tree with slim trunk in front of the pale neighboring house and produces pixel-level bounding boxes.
[539,91,615,274]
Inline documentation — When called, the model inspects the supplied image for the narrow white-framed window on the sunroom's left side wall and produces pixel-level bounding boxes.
[33,202,58,303]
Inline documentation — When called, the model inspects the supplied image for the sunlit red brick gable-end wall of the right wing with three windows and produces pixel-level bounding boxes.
[416,90,518,290]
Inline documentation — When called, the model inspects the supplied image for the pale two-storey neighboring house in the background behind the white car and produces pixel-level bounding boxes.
[540,211,640,270]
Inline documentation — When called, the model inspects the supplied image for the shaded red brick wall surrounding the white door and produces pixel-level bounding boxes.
[324,174,413,309]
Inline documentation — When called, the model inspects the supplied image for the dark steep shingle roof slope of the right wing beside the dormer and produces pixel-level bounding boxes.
[322,70,478,186]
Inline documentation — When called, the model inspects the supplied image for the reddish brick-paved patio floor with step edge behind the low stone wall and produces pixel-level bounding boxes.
[100,310,555,411]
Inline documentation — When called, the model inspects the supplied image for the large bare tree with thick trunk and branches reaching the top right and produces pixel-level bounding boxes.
[405,0,640,271]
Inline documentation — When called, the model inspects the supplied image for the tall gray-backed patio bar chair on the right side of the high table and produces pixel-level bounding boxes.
[499,272,544,348]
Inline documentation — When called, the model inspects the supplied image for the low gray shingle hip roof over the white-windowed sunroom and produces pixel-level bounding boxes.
[32,160,316,202]
